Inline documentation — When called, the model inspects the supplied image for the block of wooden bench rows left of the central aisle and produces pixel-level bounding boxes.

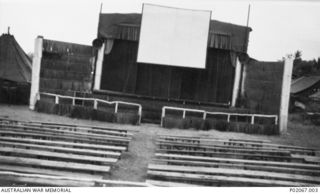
[0,118,139,186]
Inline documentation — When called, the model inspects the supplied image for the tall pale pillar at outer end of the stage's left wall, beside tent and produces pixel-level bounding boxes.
[29,36,43,110]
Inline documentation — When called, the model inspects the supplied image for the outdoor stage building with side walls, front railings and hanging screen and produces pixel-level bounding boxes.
[30,6,292,134]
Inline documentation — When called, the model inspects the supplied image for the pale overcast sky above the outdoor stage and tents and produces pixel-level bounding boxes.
[0,0,320,61]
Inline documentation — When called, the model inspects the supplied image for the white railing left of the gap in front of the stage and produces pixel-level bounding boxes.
[37,92,142,124]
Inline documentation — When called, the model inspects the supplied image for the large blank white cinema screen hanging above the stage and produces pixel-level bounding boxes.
[137,4,211,68]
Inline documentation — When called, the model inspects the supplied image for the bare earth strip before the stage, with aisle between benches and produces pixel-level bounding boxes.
[0,104,320,182]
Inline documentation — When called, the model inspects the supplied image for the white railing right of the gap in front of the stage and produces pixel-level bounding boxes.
[161,106,278,127]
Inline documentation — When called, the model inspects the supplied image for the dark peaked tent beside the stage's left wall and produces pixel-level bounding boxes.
[0,33,31,104]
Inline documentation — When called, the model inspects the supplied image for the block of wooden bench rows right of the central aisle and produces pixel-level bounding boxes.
[147,135,320,186]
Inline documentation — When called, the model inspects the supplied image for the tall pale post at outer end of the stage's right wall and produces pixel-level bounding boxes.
[279,57,293,134]
